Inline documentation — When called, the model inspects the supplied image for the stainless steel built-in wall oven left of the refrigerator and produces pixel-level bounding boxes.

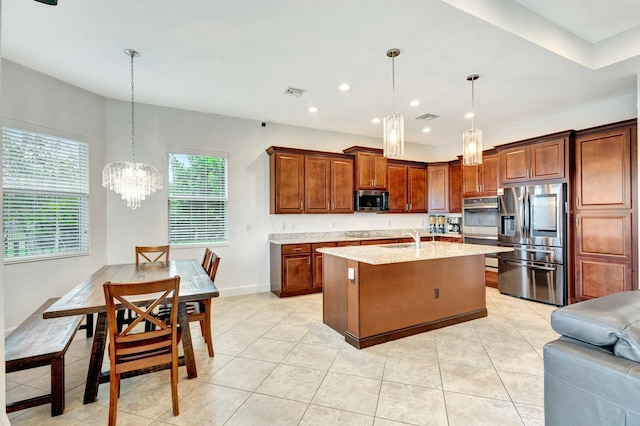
[462,197,499,274]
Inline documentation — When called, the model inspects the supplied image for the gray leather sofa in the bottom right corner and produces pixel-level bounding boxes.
[544,291,640,426]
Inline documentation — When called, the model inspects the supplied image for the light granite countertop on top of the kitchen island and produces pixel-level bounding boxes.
[318,241,513,265]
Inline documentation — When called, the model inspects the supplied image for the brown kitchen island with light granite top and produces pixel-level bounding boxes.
[318,242,512,348]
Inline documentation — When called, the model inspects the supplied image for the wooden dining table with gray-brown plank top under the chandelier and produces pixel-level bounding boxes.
[42,259,219,404]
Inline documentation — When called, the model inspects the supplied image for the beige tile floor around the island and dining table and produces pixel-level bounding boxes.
[7,288,557,426]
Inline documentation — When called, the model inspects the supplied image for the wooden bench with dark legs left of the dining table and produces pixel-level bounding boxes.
[4,298,82,416]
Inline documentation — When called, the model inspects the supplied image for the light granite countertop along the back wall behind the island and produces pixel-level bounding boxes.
[267,229,462,244]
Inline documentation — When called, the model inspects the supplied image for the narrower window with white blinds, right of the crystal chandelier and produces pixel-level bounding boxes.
[169,153,228,245]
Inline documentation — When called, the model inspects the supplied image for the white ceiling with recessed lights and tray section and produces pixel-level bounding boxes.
[1,0,640,153]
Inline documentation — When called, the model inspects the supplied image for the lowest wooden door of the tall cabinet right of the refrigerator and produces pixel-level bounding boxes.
[576,256,632,301]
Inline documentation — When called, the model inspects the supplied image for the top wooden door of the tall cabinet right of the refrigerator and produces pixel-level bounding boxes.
[575,128,632,209]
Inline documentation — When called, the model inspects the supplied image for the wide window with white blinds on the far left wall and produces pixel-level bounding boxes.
[2,127,89,261]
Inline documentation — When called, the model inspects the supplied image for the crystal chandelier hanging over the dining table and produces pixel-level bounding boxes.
[102,49,162,210]
